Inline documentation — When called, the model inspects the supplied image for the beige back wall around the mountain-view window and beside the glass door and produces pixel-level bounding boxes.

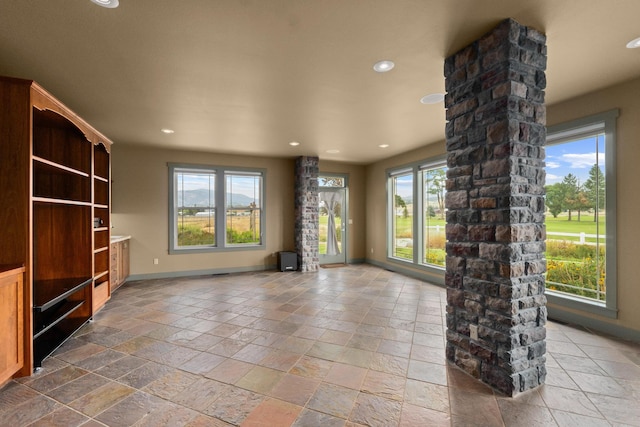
[112,149,365,278]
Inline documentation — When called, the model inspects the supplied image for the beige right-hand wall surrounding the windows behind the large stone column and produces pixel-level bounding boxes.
[366,79,640,339]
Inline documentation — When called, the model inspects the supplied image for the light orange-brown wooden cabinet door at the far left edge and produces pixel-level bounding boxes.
[0,268,24,385]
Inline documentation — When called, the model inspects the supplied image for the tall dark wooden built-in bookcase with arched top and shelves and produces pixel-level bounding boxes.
[0,77,112,375]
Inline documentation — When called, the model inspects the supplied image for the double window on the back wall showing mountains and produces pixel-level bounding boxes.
[169,164,265,254]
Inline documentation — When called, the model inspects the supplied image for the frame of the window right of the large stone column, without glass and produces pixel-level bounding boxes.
[545,109,619,319]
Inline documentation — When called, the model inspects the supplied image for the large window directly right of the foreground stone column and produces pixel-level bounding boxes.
[545,111,617,317]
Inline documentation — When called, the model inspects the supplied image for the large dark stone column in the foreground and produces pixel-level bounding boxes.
[445,19,547,396]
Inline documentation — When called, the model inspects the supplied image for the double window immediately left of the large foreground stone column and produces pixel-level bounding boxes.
[388,159,446,268]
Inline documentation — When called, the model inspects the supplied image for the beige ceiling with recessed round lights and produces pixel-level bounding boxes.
[0,0,640,164]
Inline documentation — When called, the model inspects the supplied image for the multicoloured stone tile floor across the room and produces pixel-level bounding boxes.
[0,265,640,427]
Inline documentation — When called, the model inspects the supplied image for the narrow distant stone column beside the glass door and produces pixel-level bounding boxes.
[295,157,320,271]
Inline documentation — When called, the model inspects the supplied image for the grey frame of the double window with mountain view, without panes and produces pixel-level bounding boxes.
[168,163,266,255]
